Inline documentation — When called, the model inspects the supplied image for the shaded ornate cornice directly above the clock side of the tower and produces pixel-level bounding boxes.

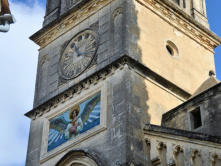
[30,0,113,48]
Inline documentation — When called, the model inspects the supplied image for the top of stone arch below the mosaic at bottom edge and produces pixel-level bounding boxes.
[56,151,101,166]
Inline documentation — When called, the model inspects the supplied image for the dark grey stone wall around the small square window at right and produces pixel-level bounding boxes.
[162,83,221,136]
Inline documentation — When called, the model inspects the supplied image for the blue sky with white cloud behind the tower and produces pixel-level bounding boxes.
[0,0,221,166]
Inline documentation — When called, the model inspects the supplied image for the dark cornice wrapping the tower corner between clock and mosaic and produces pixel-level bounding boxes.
[25,55,191,120]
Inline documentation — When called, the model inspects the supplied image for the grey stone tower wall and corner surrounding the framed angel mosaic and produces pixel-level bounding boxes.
[26,65,150,166]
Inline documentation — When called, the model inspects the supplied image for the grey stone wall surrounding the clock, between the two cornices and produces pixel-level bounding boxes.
[34,0,128,107]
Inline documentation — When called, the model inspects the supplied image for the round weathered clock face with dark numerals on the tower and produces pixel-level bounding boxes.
[59,30,98,79]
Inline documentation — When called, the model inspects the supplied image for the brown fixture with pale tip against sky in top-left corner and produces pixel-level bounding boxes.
[0,0,15,32]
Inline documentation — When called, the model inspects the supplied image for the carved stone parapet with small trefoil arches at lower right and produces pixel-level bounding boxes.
[144,125,221,166]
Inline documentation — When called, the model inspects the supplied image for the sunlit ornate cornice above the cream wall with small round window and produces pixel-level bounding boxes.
[136,0,221,52]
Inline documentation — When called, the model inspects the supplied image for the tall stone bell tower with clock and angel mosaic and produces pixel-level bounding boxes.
[26,0,221,166]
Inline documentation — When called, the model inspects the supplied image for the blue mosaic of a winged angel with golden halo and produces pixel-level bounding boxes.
[48,93,101,151]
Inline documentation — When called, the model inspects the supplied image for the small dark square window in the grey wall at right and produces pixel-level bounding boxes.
[190,107,202,130]
